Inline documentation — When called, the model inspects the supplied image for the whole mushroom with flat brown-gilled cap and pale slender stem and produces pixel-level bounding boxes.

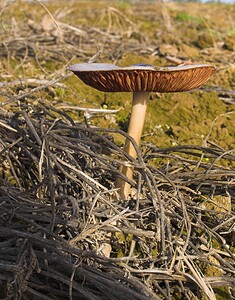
[69,63,216,199]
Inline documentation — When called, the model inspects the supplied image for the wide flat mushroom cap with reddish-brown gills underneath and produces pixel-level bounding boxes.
[68,63,216,92]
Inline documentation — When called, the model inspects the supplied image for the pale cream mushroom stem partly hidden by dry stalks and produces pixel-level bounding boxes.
[116,92,149,199]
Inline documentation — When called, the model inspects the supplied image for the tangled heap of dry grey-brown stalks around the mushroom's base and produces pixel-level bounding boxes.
[0,101,235,299]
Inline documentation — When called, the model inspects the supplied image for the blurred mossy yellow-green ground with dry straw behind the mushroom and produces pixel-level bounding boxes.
[0,0,235,149]
